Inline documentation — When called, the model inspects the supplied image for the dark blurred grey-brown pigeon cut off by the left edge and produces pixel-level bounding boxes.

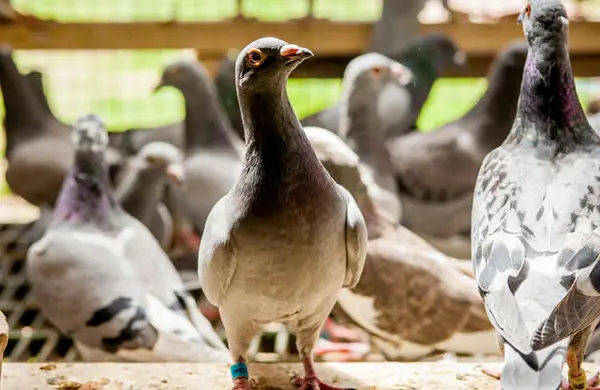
[0,46,73,207]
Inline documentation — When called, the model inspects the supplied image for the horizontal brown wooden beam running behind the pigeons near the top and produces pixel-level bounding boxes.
[0,18,600,56]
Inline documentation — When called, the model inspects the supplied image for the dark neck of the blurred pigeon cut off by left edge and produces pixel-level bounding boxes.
[0,55,49,154]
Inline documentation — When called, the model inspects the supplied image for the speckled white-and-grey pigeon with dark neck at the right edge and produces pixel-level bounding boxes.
[471,0,600,390]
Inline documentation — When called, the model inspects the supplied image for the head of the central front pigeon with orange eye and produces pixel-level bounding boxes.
[235,38,314,88]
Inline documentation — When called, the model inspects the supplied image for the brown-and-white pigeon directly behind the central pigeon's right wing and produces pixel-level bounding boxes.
[304,127,499,360]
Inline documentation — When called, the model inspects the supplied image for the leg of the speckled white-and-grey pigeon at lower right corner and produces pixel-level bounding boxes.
[561,327,600,390]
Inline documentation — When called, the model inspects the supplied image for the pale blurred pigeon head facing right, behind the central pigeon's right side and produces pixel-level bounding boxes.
[344,53,413,92]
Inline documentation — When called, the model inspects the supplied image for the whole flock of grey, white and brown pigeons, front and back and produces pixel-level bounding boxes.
[0,0,600,390]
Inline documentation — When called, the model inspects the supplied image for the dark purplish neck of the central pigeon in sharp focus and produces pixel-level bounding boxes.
[235,82,333,213]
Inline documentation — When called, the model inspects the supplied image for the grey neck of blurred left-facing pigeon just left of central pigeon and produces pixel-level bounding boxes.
[181,79,239,151]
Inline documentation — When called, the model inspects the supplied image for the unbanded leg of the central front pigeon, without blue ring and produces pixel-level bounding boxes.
[292,320,353,390]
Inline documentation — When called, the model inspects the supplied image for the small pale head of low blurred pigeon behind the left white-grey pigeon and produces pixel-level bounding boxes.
[137,141,184,184]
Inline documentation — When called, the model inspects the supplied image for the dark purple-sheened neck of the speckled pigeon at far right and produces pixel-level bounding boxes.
[507,36,597,143]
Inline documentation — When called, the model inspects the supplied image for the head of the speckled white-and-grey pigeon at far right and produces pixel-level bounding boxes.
[518,0,569,44]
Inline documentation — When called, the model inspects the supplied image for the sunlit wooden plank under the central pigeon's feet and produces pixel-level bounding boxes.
[2,362,508,390]
